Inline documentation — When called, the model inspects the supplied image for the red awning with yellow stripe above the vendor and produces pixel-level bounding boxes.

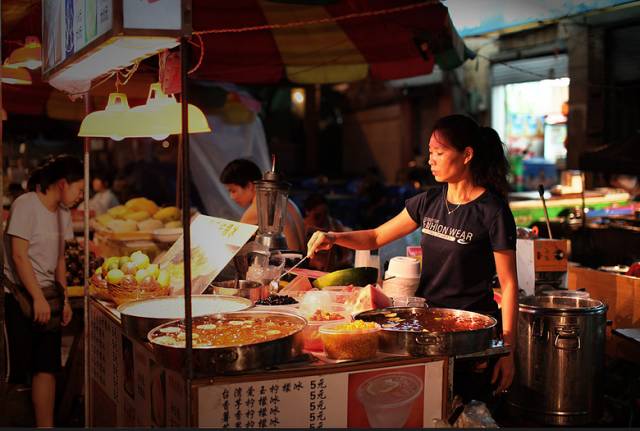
[191,0,472,84]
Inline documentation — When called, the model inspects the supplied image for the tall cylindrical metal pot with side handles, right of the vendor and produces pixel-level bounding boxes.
[508,296,607,426]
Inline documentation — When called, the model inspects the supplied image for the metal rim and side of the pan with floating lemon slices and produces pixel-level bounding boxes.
[148,310,307,376]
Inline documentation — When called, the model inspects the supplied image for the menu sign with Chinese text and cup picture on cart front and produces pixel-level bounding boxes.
[198,361,444,428]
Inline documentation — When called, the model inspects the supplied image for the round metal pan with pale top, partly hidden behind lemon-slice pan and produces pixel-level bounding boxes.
[118,295,253,341]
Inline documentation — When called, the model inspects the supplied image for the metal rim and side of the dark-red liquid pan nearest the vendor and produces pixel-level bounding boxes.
[355,307,497,356]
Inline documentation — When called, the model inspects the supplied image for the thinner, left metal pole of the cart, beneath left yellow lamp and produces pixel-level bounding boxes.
[83,92,92,427]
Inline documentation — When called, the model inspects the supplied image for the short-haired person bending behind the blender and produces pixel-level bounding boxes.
[220,159,306,252]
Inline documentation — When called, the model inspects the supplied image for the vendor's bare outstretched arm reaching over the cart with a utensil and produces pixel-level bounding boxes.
[307,208,418,255]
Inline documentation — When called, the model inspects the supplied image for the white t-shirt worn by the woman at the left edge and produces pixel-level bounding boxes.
[4,192,73,291]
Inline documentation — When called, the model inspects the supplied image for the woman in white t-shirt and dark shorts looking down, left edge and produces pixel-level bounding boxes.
[2,155,84,427]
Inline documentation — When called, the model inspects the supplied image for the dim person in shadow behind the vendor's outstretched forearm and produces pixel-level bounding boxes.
[303,193,353,272]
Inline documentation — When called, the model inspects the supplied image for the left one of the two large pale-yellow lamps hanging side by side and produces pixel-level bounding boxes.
[78,93,138,141]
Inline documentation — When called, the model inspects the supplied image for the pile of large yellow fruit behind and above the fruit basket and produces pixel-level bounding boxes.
[95,198,182,233]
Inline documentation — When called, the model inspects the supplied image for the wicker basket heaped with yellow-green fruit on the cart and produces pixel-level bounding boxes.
[91,251,171,305]
